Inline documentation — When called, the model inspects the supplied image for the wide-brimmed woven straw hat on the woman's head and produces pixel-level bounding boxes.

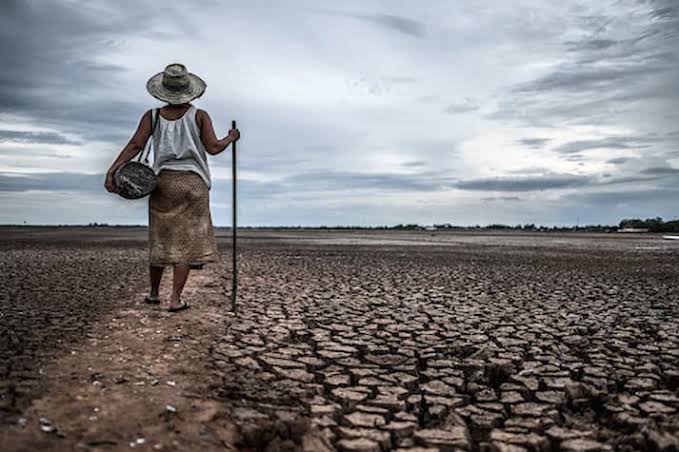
[146,63,206,104]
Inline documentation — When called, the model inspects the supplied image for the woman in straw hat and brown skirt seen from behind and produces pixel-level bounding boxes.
[106,64,240,312]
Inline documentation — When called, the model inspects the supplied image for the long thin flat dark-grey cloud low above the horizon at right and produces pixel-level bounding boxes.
[454,174,591,192]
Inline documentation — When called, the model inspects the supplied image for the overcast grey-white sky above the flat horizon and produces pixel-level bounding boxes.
[0,0,679,225]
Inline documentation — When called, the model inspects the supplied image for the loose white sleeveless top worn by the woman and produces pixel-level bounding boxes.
[151,105,212,188]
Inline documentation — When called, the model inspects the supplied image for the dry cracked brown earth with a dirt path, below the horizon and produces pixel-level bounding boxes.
[0,228,679,452]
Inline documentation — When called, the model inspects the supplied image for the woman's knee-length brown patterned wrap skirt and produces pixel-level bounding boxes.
[149,171,219,267]
